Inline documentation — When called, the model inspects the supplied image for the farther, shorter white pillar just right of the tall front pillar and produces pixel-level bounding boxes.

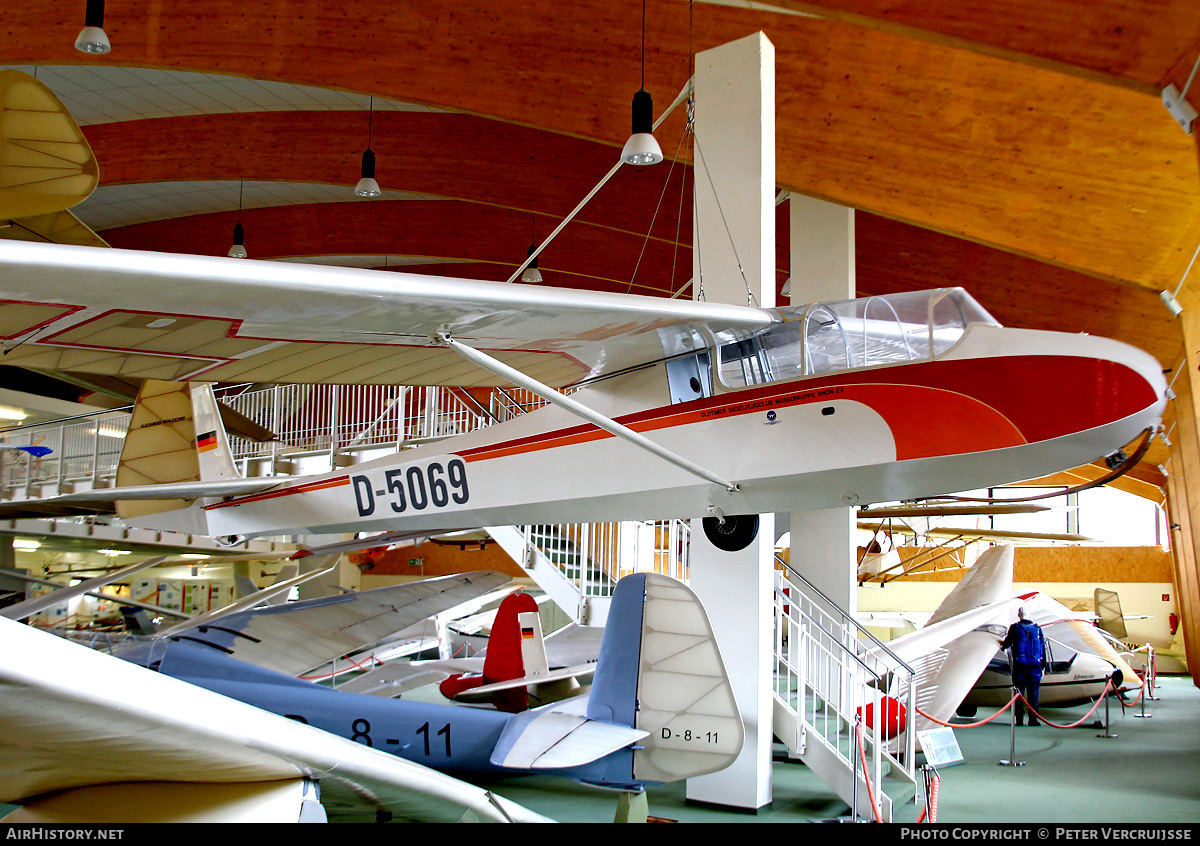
[779,194,858,613]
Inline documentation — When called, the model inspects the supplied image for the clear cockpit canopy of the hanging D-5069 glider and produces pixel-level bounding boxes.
[718,288,1000,389]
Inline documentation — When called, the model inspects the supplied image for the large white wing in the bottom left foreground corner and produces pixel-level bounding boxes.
[0,619,544,822]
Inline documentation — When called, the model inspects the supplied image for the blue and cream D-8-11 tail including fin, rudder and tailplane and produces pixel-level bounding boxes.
[491,574,745,791]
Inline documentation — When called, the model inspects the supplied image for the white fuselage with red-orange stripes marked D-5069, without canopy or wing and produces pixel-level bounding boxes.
[194,324,1165,535]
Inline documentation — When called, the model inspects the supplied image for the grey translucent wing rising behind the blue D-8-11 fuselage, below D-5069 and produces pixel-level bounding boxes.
[164,572,510,676]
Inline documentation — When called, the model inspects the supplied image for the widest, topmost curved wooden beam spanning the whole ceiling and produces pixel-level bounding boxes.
[0,0,1200,290]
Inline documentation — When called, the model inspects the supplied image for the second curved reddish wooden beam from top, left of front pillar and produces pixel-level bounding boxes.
[84,112,691,244]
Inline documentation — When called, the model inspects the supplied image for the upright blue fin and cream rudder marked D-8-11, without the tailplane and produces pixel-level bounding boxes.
[587,574,745,782]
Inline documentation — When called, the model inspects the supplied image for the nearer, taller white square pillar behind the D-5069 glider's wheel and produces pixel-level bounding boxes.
[688,32,775,810]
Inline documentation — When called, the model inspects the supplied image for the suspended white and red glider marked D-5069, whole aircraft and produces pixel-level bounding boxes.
[0,241,1166,551]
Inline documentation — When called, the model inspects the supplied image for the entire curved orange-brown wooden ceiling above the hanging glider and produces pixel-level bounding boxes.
[0,0,1200,489]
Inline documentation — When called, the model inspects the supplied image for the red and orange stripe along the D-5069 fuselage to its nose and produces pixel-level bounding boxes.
[206,355,1156,508]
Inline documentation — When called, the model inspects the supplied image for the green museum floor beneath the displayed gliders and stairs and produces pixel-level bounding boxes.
[472,677,1200,823]
